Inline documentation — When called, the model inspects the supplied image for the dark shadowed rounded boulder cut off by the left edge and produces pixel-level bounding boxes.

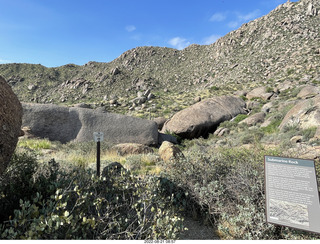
[0,76,23,175]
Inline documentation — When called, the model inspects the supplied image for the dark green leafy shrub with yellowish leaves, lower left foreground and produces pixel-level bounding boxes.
[0,152,182,239]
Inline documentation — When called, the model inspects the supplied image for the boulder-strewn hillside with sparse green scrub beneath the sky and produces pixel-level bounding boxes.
[0,0,320,117]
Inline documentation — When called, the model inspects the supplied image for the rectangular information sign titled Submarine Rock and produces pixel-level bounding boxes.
[264,156,320,233]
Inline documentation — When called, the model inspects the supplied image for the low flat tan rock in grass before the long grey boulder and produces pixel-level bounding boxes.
[111,143,153,156]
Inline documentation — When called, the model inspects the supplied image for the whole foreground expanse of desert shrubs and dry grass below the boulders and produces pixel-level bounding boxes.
[0,130,320,239]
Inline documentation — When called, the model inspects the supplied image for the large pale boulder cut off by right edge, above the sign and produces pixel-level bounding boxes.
[279,95,320,130]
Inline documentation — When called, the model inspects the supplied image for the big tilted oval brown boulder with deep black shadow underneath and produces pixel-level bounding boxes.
[161,96,246,139]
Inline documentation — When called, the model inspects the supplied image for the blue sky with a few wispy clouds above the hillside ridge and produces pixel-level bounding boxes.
[0,0,296,67]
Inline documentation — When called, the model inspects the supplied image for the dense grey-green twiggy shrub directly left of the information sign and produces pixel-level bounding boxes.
[161,148,319,239]
